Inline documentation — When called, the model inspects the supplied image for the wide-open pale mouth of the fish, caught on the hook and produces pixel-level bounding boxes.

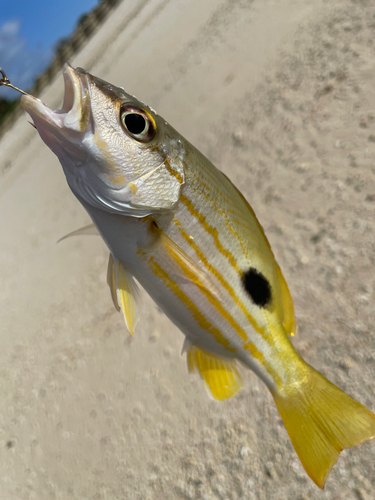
[21,63,91,139]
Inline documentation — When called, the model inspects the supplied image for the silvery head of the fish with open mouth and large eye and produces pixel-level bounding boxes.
[21,64,185,217]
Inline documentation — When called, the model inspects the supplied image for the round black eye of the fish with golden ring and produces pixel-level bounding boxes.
[120,104,156,142]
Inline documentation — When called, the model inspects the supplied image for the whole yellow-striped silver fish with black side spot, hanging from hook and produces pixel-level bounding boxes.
[21,64,375,488]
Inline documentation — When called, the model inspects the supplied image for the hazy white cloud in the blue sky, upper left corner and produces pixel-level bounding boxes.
[0,19,53,99]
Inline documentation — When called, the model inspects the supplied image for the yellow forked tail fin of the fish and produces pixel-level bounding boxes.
[273,365,375,488]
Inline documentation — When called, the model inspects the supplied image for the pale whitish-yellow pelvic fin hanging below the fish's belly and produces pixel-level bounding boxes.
[107,254,138,335]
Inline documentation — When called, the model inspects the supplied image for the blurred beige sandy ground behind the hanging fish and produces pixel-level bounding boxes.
[0,0,375,500]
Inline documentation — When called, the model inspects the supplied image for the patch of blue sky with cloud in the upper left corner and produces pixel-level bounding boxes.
[0,0,98,99]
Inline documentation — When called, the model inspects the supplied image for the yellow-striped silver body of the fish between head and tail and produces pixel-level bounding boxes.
[81,138,291,387]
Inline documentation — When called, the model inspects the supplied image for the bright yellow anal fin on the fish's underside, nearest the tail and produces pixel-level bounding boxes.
[187,345,243,401]
